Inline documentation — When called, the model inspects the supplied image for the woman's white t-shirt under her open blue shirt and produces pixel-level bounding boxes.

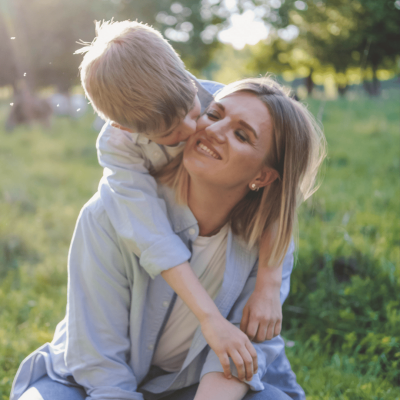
[152,225,228,372]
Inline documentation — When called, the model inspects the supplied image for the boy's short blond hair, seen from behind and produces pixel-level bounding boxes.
[75,21,197,134]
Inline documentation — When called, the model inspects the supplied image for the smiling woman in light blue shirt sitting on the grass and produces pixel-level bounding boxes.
[11,79,324,400]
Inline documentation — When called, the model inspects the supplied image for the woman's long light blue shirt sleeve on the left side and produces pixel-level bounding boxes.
[65,198,143,400]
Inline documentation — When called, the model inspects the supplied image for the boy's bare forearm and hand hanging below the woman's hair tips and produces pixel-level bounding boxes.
[240,233,287,342]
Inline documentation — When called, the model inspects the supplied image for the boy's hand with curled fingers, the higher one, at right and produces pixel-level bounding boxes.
[240,288,282,343]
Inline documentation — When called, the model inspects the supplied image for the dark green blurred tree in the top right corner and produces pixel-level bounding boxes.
[279,0,400,94]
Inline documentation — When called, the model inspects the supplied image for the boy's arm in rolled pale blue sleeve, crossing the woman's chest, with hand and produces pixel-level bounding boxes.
[97,122,256,379]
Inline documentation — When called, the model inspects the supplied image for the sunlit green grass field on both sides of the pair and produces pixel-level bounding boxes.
[0,89,400,400]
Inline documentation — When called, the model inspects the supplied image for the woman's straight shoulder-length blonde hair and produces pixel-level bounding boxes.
[156,78,326,266]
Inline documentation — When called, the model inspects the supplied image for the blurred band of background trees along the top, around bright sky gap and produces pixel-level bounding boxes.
[0,0,400,93]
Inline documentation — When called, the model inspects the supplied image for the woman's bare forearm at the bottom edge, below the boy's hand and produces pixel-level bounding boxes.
[194,372,249,400]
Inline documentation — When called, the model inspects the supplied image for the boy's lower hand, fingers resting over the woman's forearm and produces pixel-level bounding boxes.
[200,314,258,381]
